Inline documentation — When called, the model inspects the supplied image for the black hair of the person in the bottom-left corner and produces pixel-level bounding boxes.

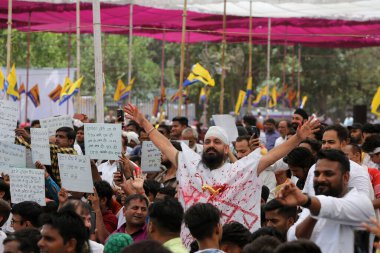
[3,228,41,253]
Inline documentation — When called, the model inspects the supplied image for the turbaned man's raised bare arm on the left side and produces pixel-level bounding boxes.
[124,103,178,167]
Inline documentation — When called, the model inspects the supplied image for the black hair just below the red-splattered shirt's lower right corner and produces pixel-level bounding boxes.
[220,221,251,248]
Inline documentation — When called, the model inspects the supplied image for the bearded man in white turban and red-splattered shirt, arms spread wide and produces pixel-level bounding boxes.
[124,104,319,239]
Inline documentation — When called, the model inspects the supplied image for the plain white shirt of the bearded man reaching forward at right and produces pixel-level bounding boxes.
[287,188,375,253]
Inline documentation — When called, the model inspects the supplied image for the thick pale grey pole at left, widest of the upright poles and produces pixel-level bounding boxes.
[92,0,104,123]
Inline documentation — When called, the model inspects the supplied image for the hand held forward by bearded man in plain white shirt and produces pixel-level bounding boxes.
[276,182,307,206]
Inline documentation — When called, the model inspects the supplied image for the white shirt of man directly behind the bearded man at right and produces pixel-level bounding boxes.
[303,160,373,199]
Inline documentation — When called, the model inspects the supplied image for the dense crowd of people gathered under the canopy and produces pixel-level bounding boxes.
[0,104,380,253]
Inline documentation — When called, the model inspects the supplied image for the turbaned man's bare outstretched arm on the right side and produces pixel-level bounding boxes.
[257,117,319,175]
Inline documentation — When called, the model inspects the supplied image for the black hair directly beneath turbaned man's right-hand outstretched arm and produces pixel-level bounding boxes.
[283,147,315,169]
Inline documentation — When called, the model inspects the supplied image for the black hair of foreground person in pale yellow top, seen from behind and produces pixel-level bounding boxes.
[148,197,183,235]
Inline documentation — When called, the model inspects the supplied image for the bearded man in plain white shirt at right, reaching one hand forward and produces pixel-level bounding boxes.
[277,149,375,253]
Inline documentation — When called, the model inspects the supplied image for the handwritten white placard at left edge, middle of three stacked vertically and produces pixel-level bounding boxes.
[0,142,26,173]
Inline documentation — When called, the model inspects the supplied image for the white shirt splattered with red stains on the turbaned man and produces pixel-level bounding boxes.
[177,143,261,245]
